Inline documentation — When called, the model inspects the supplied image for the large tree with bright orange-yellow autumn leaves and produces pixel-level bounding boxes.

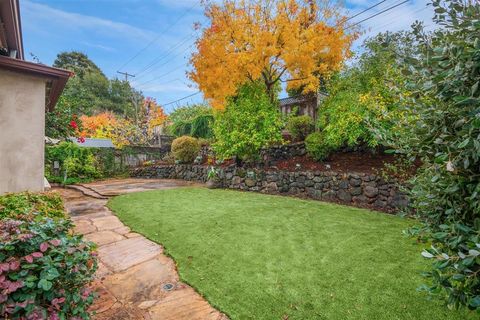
[189,0,356,109]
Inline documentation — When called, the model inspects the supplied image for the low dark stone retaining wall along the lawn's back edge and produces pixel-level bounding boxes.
[131,165,408,211]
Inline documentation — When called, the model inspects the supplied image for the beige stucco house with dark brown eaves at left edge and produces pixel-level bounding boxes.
[0,0,71,194]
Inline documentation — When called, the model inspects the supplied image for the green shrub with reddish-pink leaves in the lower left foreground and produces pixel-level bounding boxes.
[0,194,97,319]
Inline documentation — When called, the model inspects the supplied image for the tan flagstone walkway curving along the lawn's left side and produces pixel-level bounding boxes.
[54,179,228,320]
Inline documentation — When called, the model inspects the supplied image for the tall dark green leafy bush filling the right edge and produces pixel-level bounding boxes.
[397,0,480,311]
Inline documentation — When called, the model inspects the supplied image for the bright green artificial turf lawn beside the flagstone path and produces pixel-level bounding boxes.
[109,188,474,320]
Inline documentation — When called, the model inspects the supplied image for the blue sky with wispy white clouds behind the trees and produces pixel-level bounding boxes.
[20,0,433,110]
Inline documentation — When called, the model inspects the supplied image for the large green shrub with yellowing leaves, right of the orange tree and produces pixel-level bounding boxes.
[317,32,413,148]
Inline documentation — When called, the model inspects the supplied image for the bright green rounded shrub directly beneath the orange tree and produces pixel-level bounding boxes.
[213,83,283,160]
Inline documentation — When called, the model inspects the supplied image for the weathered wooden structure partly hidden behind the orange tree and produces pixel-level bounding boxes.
[278,93,326,122]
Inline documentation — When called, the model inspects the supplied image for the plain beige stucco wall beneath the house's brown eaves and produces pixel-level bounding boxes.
[0,69,45,194]
